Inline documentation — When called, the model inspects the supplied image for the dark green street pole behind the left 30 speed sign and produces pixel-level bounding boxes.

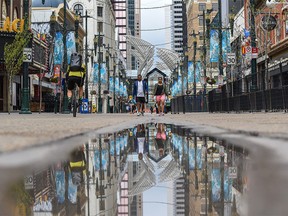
[19,0,32,114]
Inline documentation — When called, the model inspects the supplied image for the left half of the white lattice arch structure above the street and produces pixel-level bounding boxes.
[126,35,155,76]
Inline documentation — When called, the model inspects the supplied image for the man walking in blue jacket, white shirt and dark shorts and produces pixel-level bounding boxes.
[133,74,148,116]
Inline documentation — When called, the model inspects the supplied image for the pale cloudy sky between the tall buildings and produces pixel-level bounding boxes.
[141,0,172,45]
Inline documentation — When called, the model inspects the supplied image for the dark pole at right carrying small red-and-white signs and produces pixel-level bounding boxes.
[250,0,257,91]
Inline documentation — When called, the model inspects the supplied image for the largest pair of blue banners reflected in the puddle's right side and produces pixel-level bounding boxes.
[211,168,232,202]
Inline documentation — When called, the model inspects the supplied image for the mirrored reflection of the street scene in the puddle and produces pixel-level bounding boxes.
[4,123,248,216]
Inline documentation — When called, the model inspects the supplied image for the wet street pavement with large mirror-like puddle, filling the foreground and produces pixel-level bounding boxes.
[0,113,288,216]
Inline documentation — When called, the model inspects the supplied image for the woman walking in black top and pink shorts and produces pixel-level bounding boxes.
[154,77,168,116]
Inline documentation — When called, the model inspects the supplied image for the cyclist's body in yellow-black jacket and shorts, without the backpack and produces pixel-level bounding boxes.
[66,64,86,110]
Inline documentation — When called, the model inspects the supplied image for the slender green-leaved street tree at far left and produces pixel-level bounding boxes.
[4,31,31,114]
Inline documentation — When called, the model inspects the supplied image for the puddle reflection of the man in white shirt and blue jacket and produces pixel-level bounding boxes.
[134,124,148,160]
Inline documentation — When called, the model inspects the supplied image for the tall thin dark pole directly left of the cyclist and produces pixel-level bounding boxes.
[60,0,70,114]
